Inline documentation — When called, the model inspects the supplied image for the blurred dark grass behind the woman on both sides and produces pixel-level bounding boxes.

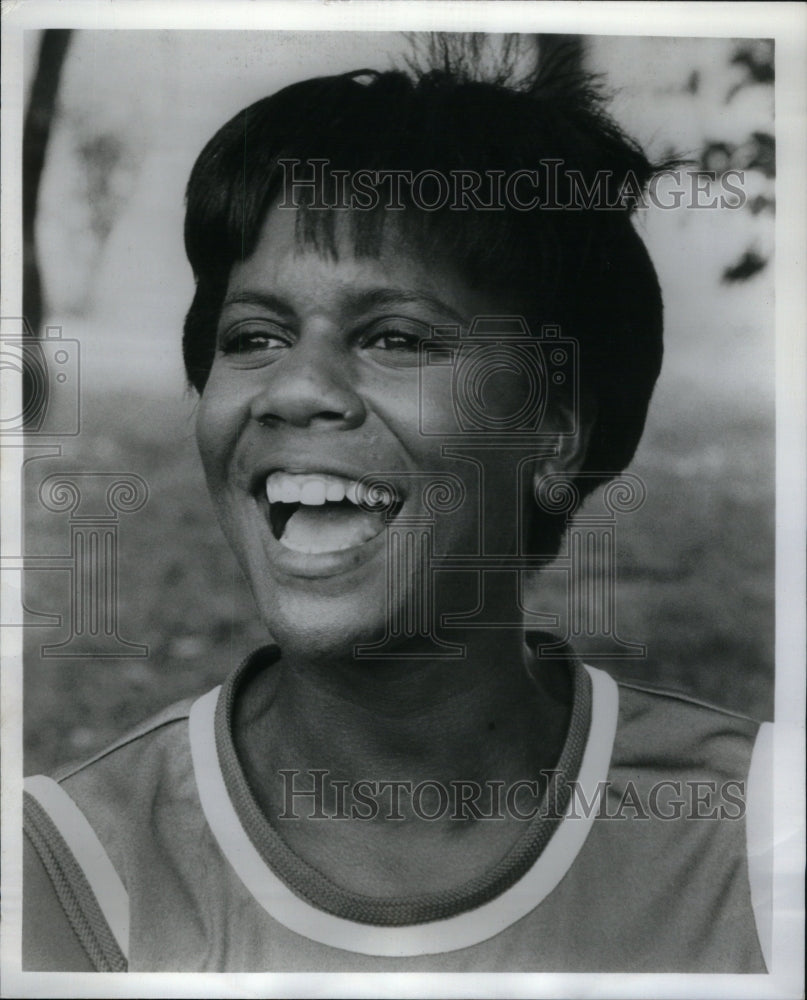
[24,380,774,773]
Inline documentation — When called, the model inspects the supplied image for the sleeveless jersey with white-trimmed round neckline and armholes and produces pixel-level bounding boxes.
[23,647,770,973]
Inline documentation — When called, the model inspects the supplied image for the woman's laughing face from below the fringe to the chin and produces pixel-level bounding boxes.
[197,208,548,655]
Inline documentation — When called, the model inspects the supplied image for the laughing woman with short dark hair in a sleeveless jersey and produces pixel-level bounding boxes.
[25,41,765,972]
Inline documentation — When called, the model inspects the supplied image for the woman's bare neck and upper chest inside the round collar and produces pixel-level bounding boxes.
[234,630,571,896]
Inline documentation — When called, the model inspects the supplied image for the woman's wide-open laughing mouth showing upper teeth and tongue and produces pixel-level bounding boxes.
[266,471,402,554]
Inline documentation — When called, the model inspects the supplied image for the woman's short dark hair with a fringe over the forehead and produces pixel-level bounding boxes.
[183,47,664,548]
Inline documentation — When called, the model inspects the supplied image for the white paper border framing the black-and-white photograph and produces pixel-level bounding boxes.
[0,0,807,1000]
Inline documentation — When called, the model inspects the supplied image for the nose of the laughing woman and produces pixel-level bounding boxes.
[251,338,366,430]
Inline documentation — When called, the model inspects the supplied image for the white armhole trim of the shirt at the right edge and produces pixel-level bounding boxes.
[745,722,773,969]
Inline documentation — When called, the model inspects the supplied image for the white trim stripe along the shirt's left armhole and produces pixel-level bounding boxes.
[24,774,129,959]
